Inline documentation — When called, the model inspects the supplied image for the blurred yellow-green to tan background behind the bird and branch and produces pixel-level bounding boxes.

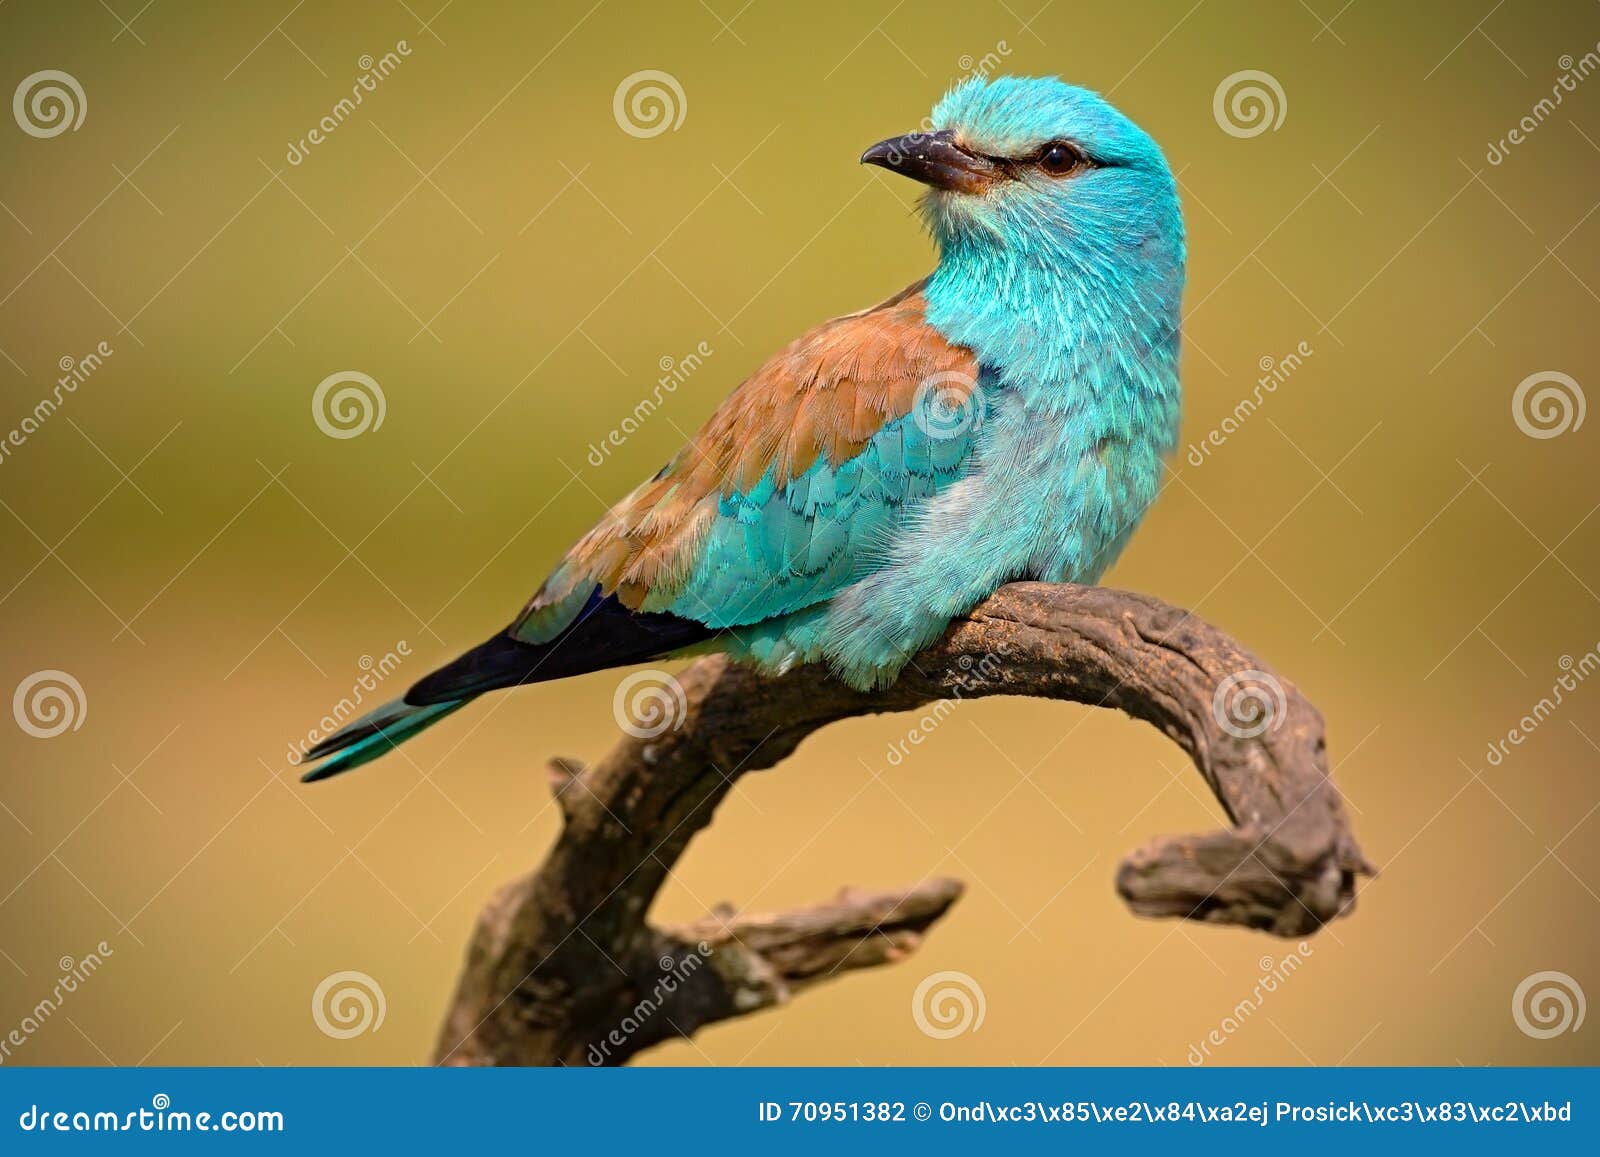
[0,0,1600,1066]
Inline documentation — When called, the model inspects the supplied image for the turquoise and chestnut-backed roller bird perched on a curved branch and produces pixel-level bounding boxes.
[304,77,1184,781]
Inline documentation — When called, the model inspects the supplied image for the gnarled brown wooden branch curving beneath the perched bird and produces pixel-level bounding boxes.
[435,583,1373,1064]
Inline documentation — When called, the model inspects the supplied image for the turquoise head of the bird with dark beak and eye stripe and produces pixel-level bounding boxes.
[861,77,1182,267]
